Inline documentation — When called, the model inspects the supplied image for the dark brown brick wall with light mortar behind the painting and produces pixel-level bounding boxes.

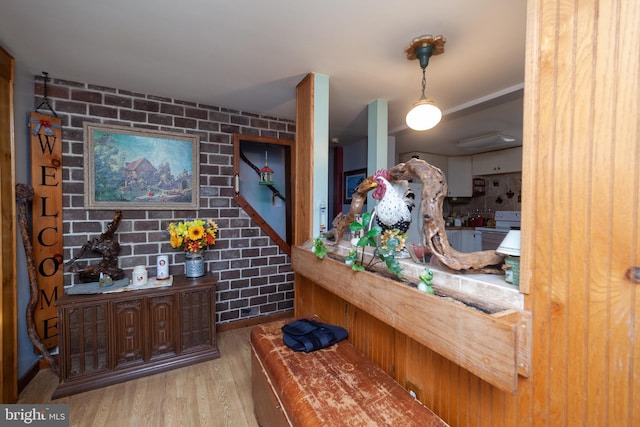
[34,77,295,323]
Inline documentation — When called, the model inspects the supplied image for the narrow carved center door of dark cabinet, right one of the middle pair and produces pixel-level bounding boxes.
[148,295,177,360]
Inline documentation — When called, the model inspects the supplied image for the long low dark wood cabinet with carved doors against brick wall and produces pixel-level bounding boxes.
[52,274,220,399]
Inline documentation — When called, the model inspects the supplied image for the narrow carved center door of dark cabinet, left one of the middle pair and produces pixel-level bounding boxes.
[113,298,144,368]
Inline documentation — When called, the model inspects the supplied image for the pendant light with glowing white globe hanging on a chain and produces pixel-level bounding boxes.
[404,35,446,130]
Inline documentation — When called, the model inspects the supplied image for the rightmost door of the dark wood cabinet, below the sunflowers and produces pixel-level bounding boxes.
[180,288,215,352]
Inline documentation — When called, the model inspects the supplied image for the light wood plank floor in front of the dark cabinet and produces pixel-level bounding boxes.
[18,327,258,427]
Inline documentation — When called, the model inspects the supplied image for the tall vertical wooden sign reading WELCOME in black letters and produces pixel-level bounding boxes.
[29,113,64,348]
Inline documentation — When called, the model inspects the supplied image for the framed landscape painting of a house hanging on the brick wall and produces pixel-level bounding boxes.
[83,122,200,210]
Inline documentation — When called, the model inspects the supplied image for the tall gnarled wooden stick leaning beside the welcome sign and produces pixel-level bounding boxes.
[16,184,59,374]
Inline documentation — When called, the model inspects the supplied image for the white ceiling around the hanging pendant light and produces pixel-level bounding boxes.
[0,0,526,155]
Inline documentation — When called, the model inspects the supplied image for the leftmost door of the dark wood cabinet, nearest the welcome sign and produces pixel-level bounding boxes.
[59,303,111,381]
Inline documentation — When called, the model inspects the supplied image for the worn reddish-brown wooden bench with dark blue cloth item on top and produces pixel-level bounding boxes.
[251,320,447,427]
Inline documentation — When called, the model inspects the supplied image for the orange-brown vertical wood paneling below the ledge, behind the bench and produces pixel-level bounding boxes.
[296,276,518,426]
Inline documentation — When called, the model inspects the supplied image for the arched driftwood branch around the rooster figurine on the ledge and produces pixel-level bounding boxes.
[333,159,503,274]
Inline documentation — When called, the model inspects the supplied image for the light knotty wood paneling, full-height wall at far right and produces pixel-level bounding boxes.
[521,1,640,425]
